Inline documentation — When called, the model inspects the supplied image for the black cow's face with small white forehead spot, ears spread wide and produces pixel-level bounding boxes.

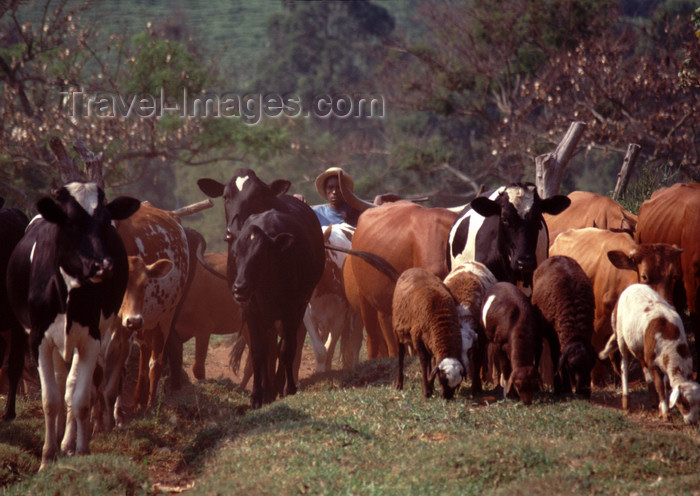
[197,169,290,243]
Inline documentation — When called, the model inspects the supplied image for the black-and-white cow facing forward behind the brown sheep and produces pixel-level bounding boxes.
[447,183,571,288]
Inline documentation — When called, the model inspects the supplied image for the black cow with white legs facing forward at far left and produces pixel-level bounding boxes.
[7,182,140,468]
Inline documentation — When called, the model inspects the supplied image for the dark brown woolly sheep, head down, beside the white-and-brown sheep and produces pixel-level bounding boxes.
[532,255,596,398]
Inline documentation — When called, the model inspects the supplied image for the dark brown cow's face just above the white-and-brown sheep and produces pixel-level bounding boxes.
[608,243,683,304]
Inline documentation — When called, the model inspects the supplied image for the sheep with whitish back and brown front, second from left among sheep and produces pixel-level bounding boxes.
[445,261,497,395]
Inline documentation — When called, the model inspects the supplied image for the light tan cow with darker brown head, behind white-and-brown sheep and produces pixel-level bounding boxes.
[549,227,681,384]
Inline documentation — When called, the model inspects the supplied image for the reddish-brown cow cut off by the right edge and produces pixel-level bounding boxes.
[636,183,700,360]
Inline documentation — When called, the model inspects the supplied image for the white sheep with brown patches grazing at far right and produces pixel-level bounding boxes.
[600,284,700,424]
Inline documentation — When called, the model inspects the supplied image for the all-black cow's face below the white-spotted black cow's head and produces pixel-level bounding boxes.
[231,222,294,303]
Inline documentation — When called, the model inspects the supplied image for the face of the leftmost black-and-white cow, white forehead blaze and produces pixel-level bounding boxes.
[37,182,140,287]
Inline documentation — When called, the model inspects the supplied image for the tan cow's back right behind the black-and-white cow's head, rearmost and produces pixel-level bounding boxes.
[543,191,637,246]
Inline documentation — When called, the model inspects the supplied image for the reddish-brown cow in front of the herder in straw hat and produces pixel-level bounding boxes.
[343,201,457,358]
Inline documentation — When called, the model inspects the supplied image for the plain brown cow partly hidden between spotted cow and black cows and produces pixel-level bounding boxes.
[167,252,244,380]
